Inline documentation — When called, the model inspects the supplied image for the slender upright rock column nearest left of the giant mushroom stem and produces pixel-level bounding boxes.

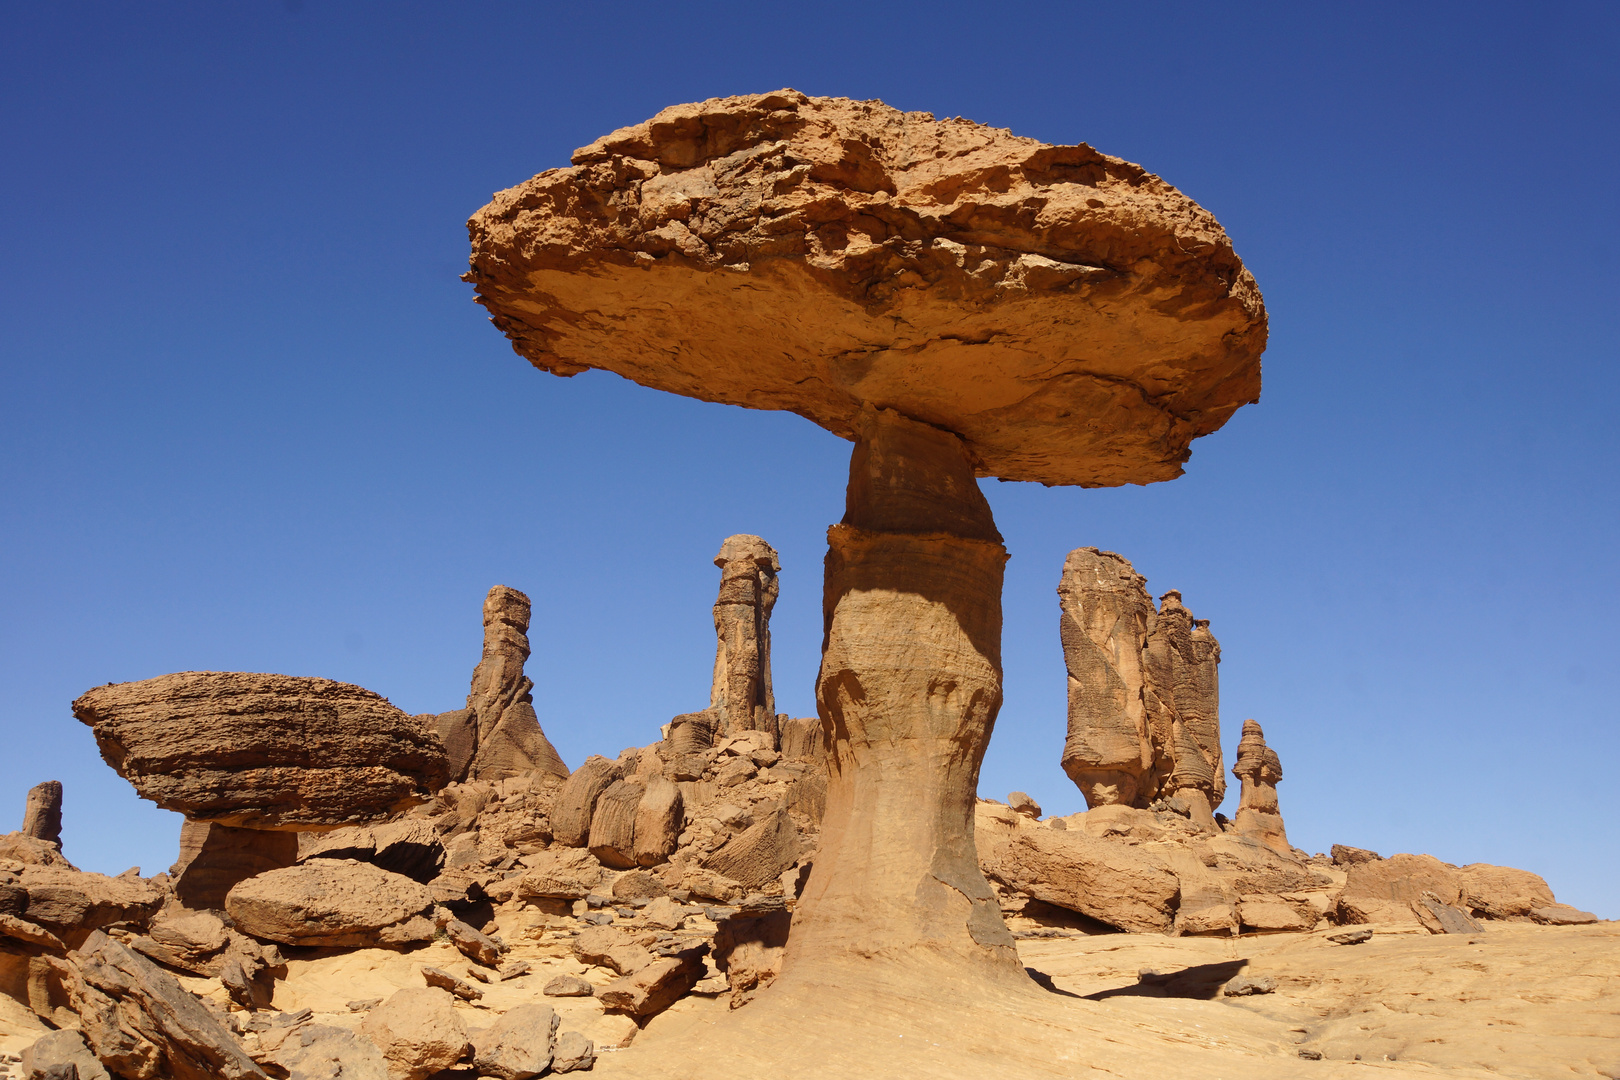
[710,534,782,742]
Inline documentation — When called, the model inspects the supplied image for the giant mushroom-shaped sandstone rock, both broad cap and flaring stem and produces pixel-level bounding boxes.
[467,91,1265,1075]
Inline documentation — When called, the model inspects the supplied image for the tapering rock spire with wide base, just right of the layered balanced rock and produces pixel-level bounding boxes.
[463,585,569,780]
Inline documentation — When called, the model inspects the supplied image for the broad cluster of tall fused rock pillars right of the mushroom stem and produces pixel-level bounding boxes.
[1058,547,1226,819]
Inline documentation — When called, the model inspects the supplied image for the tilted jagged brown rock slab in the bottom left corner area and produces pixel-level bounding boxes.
[70,931,266,1080]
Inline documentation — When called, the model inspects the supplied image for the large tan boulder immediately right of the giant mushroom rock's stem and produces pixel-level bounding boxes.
[987,829,1181,933]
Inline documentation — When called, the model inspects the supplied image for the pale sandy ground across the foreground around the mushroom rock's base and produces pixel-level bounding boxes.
[0,923,1620,1080]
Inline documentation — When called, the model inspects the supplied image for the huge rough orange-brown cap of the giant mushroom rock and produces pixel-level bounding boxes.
[468,91,1265,486]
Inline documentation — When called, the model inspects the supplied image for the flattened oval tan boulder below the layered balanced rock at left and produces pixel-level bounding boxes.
[225,858,434,947]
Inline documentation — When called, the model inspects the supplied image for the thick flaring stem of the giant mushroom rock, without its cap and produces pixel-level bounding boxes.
[782,410,1025,981]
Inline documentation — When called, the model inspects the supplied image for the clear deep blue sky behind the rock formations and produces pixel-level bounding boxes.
[0,0,1620,918]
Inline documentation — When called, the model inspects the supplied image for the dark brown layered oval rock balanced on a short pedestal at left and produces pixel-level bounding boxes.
[73,672,449,829]
